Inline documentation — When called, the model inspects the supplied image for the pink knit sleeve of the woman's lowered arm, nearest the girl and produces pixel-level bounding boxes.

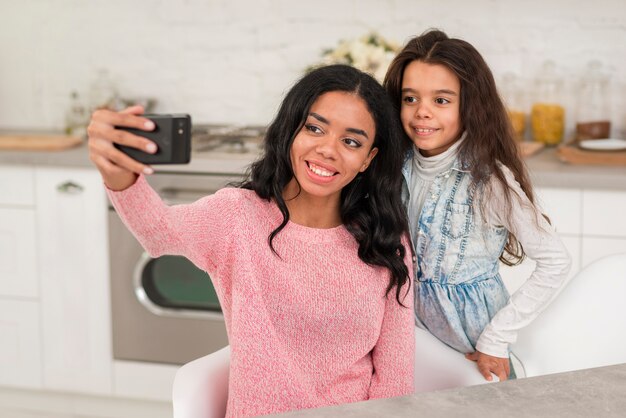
[369,238,415,399]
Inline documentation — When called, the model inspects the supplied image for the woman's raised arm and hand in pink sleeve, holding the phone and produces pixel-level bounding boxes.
[89,106,234,270]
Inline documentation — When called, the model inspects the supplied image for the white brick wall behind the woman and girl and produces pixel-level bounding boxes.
[0,0,626,137]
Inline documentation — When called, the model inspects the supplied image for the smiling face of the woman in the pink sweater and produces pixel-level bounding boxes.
[286,91,378,204]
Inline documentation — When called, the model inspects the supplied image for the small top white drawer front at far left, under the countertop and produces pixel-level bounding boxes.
[0,166,35,206]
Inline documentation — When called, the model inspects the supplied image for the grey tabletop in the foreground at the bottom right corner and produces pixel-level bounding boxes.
[274,364,626,418]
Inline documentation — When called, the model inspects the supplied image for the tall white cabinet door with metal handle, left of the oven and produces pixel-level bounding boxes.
[36,169,112,394]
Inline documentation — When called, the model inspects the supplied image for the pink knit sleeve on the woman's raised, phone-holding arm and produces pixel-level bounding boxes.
[107,176,235,271]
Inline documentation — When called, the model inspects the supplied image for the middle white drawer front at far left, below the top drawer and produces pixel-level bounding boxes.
[0,207,39,298]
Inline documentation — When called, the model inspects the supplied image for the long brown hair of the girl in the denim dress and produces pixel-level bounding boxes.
[383,29,535,265]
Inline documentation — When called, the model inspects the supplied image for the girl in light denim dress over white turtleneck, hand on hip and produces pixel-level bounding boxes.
[384,30,571,384]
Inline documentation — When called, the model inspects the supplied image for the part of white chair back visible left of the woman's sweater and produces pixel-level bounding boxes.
[172,346,230,418]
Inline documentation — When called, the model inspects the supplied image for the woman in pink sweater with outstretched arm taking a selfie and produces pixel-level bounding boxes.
[89,66,414,417]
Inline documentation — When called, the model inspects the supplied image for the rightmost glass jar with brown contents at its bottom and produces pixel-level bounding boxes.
[576,61,611,141]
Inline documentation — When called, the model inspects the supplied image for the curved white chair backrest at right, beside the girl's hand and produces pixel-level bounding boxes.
[511,253,626,377]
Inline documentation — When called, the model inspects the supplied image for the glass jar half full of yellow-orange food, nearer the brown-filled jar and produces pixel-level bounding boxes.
[530,61,565,145]
